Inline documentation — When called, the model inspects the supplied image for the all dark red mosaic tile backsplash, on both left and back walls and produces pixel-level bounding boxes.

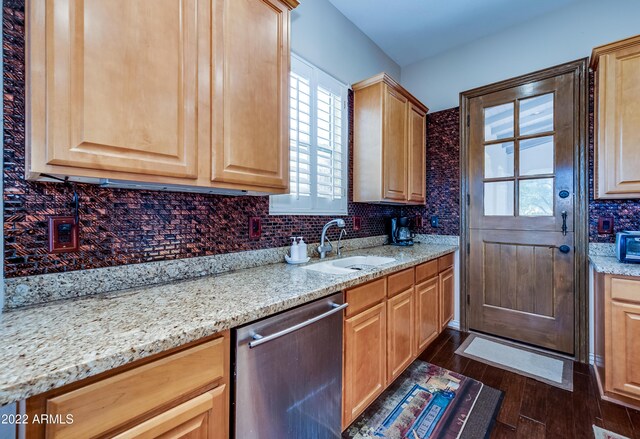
[10,0,640,277]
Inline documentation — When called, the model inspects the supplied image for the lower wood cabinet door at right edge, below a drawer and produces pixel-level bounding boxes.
[605,301,640,397]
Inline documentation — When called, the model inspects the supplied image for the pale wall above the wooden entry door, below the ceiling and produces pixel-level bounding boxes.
[401,0,640,111]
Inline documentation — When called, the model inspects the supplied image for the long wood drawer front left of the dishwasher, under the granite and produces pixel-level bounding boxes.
[47,337,229,439]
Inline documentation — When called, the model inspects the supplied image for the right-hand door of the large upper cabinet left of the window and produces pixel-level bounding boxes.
[211,0,289,192]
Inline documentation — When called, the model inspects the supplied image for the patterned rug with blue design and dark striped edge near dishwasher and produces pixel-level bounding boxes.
[342,360,502,439]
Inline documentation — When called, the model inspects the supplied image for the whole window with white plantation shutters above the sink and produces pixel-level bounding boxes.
[269,54,348,215]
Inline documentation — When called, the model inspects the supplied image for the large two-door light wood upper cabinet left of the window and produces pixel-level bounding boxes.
[26,0,297,193]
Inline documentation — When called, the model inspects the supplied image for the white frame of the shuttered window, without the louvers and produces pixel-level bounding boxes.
[269,54,349,215]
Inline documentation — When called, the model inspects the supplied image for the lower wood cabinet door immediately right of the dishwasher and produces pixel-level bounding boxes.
[342,302,387,427]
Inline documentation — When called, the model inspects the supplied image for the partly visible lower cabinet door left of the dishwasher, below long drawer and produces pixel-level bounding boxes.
[114,386,228,439]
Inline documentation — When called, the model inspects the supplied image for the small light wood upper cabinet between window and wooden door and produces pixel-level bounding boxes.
[353,73,428,204]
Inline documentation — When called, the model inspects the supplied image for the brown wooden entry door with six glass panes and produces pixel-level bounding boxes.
[468,72,579,353]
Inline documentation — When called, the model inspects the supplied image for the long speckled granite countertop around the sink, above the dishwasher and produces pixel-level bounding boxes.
[0,244,457,405]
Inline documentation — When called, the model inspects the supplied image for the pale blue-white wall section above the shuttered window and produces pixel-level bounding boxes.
[291,0,400,84]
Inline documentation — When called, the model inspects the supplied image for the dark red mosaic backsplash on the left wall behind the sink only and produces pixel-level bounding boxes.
[3,0,404,277]
